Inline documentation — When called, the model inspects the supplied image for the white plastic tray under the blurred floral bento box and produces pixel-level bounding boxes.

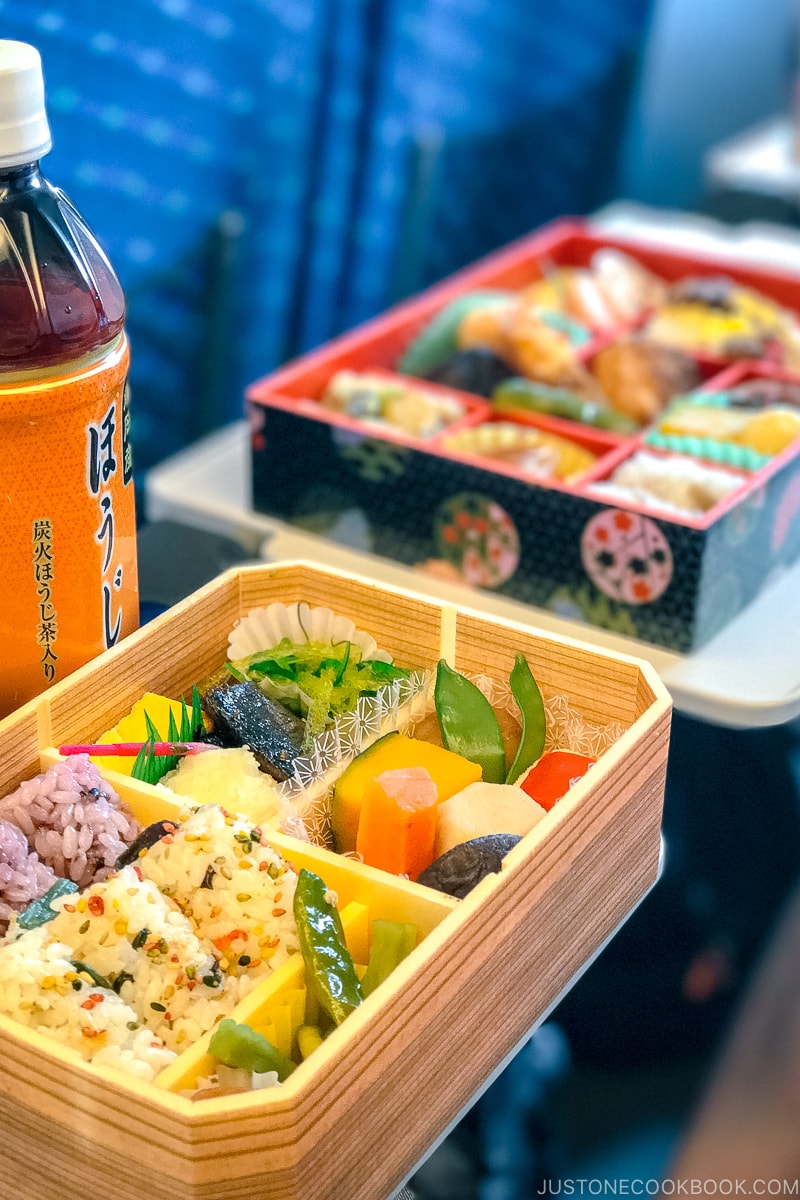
[145,421,800,728]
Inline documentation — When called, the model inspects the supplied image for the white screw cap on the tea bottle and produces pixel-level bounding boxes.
[0,38,53,168]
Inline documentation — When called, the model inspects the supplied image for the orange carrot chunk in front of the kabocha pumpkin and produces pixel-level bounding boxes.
[356,767,438,880]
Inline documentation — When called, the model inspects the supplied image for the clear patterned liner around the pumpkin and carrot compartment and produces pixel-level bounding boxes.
[289,671,627,846]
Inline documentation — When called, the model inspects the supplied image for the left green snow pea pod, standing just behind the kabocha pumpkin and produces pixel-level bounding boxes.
[433,659,506,784]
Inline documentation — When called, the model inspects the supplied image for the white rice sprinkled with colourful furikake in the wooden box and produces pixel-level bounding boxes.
[0,805,300,1079]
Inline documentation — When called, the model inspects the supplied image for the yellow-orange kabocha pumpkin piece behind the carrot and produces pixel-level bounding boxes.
[331,731,481,854]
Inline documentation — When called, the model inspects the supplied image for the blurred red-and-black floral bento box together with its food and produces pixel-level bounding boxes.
[247,221,800,652]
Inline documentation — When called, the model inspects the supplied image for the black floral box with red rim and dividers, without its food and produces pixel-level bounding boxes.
[247,221,800,652]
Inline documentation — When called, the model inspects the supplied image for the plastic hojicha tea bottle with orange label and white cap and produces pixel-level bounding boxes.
[0,41,139,716]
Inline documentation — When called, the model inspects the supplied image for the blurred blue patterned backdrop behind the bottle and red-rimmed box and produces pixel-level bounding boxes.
[0,0,794,472]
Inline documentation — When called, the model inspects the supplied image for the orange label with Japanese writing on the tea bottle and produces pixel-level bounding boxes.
[0,336,139,716]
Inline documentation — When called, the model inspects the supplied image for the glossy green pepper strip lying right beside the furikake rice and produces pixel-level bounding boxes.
[294,866,363,1025]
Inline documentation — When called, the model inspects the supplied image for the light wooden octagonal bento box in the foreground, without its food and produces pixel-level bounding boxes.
[0,563,670,1200]
